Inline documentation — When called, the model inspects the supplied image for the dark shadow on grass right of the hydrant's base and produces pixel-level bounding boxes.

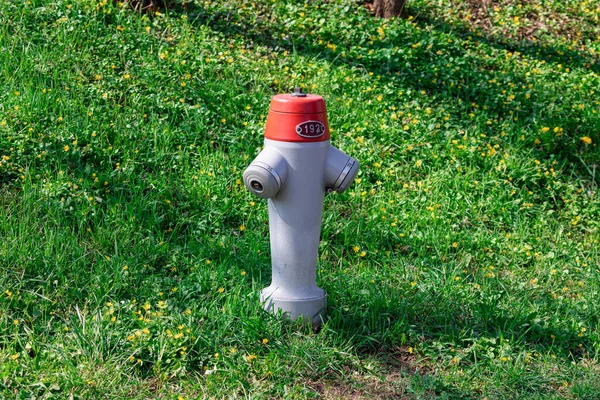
[328,268,599,364]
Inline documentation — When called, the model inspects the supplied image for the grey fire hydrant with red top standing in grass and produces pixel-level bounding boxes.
[244,88,359,325]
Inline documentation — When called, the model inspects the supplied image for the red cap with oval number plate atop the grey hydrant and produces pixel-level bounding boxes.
[265,88,329,142]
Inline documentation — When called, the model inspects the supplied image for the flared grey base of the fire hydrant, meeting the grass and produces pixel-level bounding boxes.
[260,287,327,326]
